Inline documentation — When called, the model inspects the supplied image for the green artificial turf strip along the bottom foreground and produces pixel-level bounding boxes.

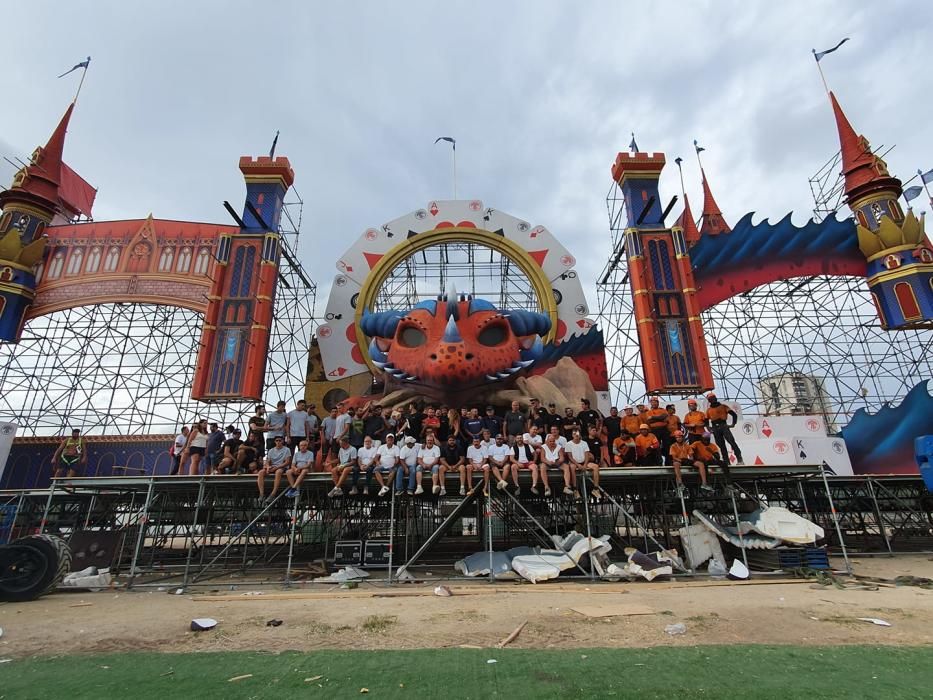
[0,646,933,700]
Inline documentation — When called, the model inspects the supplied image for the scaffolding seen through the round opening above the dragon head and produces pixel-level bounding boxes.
[374,242,538,311]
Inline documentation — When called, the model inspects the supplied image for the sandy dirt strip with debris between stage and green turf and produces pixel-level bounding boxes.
[0,555,933,658]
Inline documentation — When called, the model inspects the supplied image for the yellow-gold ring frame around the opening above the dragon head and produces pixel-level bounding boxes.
[354,227,557,373]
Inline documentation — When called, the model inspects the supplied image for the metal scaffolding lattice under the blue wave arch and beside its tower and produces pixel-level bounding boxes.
[596,178,933,429]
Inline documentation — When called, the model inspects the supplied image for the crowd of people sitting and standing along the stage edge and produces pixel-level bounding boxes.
[157,394,742,501]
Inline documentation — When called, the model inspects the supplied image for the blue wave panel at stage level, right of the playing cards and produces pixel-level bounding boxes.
[842,381,933,474]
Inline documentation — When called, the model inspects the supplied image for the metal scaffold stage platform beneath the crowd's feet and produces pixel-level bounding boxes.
[0,465,933,587]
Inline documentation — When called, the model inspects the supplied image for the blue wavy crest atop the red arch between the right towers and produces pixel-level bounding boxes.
[690,212,862,276]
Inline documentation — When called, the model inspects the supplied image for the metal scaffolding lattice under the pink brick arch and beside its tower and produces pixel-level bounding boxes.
[0,194,317,436]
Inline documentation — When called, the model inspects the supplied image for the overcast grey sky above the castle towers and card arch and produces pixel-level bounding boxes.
[0,0,933,313]
